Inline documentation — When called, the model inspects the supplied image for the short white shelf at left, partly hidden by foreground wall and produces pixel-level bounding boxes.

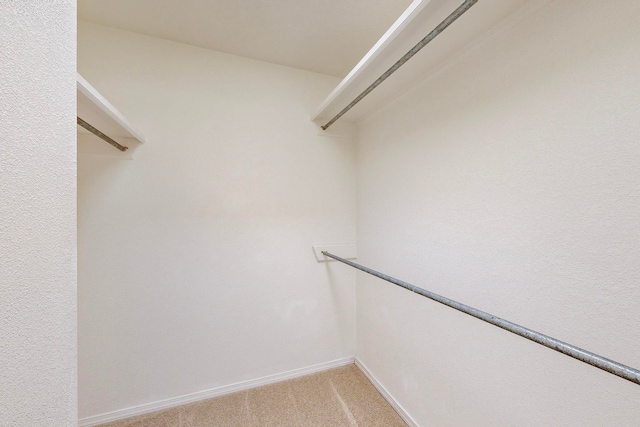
[77,74,145,158]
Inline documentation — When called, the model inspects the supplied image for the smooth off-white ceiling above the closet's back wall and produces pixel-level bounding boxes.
[78,0,411,77]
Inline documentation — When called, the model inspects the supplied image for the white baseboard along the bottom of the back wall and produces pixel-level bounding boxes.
[78,357,356,427]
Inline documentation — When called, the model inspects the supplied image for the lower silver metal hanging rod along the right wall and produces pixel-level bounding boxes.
[322,251,640,384]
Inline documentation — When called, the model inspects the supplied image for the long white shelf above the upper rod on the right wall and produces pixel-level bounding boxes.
[311,0,536,124]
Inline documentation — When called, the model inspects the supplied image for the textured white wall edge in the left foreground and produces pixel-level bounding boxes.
[0,0,77,427]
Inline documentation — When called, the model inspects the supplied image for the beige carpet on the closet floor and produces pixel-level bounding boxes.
[97,365,406,427]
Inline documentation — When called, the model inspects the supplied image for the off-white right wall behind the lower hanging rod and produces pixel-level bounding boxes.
[356,0,640,426]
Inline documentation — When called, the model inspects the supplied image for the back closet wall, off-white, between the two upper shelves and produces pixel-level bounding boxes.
[78,22,355,419]
